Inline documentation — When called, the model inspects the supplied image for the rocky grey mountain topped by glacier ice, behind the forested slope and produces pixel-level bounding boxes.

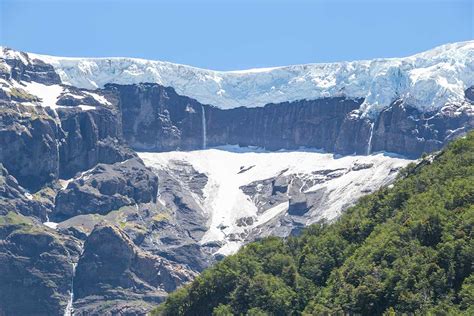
[0,41,474,314]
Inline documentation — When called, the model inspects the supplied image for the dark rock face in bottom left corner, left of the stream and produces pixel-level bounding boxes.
[0,212,80,315]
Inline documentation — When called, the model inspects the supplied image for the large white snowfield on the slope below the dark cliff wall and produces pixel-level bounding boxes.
[139,146,410,255]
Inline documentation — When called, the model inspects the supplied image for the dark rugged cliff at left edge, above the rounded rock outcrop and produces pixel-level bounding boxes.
[0,101,135,190]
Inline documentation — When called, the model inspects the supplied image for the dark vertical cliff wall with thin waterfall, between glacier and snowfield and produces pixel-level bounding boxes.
[106,84,363,151]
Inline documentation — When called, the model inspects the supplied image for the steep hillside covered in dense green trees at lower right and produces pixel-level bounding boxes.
[153,133,474,315]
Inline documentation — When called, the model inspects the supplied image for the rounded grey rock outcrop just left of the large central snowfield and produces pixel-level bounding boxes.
[51,158,158,221]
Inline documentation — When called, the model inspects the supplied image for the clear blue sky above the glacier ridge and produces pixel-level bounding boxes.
[0,0,474,70]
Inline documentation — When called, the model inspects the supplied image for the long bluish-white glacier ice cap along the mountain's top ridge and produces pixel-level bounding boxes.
[10,41,474,115]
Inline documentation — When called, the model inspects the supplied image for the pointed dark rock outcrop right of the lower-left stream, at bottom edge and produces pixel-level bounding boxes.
[74,226,194,314]
